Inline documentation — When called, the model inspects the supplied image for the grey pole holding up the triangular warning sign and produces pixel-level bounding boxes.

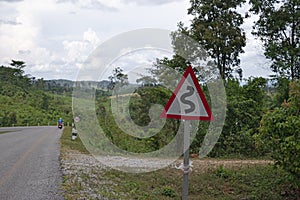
[182,120,191,200]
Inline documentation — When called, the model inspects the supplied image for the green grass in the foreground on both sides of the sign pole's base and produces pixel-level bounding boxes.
[91,165,296,200]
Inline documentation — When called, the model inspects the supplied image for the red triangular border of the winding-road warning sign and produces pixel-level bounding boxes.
[160,65,214,121]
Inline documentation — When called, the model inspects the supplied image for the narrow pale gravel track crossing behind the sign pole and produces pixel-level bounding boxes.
[62,151,274,174]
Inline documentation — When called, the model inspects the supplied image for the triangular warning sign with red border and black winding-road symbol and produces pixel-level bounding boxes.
[160,66,213,120]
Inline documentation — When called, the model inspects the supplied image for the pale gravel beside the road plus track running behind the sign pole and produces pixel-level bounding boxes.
[61,150,273,199]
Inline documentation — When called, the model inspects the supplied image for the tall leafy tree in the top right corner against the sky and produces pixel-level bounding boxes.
[250,0,300,79]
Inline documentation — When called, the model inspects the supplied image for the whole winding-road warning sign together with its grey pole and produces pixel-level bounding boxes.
[160,65,213,200]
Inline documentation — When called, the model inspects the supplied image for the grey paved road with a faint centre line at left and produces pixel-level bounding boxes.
[0,127,63,200]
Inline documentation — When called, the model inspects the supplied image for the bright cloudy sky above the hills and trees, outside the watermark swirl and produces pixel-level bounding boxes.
[0,0,271,80]
